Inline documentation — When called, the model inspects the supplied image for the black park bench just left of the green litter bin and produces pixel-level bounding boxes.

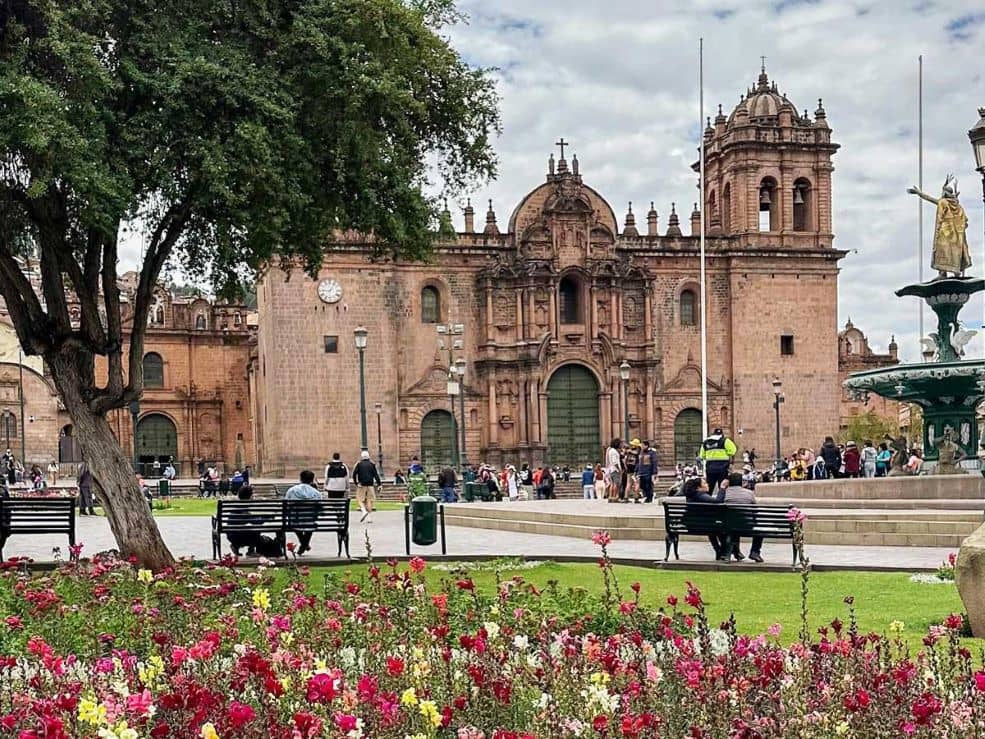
[212,499,349,559]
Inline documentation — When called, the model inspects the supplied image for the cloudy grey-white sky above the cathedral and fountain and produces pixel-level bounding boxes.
[452,0,985,360]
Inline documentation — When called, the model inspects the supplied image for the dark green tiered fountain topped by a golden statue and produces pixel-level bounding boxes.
[844,176,985,474]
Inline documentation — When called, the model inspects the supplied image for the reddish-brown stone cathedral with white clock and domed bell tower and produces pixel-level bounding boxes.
[250,69,845,475]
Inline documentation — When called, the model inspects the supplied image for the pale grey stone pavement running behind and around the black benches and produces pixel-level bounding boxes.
[4,504,952,571]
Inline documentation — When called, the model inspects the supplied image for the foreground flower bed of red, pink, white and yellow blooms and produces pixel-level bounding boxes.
[0,534,985,739]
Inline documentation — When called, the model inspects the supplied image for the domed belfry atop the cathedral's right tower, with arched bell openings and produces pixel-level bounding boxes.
[695,60,839,248]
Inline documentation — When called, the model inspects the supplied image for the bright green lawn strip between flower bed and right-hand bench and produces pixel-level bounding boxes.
[298,560,968,652]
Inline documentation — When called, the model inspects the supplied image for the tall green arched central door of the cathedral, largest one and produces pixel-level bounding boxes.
[547,364,602,470]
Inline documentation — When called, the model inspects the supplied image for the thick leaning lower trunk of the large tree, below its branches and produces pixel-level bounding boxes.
[46,353,174,571]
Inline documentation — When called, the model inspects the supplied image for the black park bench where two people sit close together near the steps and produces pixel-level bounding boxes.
[661,498,798,567]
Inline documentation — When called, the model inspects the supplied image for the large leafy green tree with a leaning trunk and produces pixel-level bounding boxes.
[0,0,499,568]
